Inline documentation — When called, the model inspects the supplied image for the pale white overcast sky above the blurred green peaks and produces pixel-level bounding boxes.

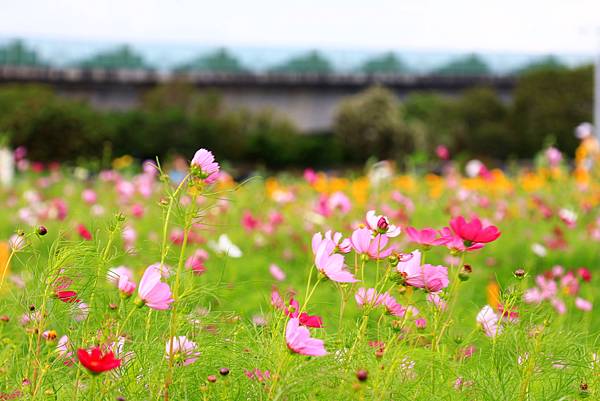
[0,0,600,54]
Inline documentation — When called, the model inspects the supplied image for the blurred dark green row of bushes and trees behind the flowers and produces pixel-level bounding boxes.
[0,63,593,168]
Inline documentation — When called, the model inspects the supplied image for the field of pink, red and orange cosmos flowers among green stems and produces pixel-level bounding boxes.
[0,148,600,401]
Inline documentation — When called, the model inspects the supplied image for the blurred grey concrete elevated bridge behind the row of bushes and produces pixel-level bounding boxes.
[0,66,516,132]
